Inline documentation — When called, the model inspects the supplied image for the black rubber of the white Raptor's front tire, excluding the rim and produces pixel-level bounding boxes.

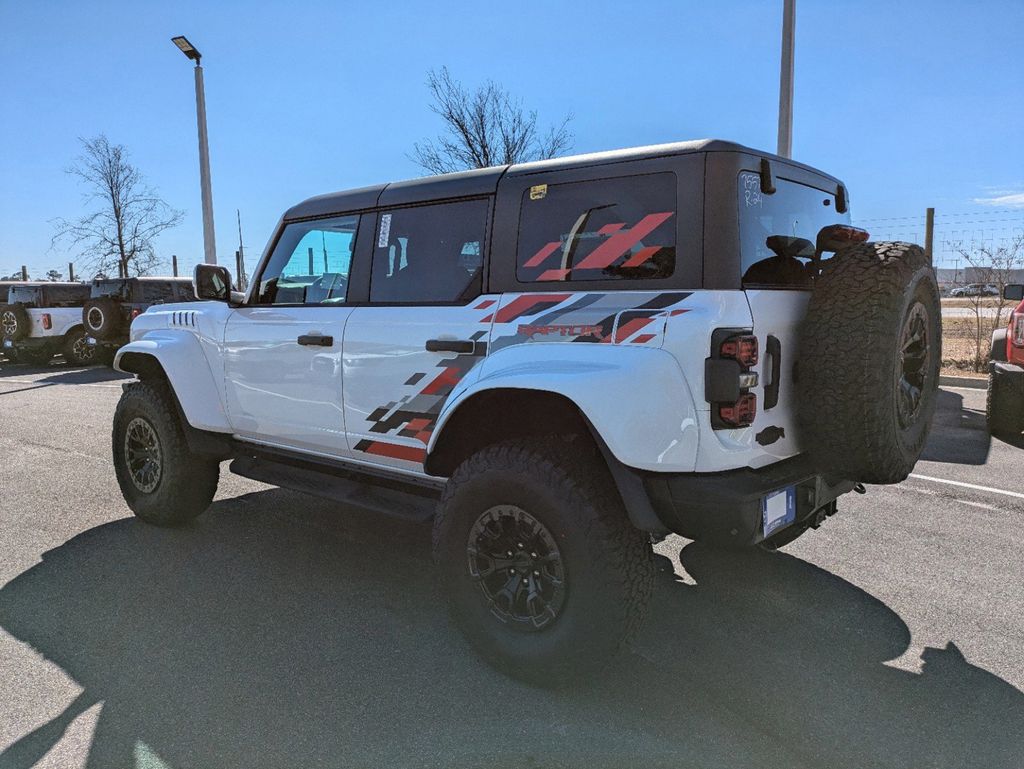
[112,380,220,526]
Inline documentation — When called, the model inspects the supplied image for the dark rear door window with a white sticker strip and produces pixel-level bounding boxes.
[370,200,487,303]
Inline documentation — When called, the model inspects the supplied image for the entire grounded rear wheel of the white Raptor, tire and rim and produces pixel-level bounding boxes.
[433,439,654,686]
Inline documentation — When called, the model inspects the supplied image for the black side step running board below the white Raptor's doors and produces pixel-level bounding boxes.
[230,457,440,521]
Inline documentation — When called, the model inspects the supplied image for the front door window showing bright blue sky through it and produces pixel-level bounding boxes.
[256,215,359,304]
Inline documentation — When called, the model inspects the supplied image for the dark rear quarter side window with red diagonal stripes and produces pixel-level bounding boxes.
[516,173,676,283]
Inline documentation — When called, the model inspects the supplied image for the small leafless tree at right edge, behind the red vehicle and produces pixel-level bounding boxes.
[954,234,1024,371]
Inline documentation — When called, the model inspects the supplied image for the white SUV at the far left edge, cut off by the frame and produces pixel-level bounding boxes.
[0,283,96,366]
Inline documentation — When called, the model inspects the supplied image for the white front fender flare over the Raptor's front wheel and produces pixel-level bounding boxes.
[114,329,231,433]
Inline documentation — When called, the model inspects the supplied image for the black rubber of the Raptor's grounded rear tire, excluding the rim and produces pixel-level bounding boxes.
[433,438,654,686]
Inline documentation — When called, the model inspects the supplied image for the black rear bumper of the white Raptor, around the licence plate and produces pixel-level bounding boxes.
[642,455,854,547]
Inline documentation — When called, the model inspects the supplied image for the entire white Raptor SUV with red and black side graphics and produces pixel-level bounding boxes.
[113,140,940,684]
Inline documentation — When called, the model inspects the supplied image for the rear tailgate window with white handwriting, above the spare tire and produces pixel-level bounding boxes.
[737,171,850,288]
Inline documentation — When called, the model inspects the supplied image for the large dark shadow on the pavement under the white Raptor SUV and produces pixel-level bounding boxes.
[0,489,1024,769]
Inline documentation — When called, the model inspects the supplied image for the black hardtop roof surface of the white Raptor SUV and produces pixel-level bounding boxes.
[284,139,841,221]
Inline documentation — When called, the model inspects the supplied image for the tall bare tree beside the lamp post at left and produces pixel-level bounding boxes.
[51,135,183,275]
